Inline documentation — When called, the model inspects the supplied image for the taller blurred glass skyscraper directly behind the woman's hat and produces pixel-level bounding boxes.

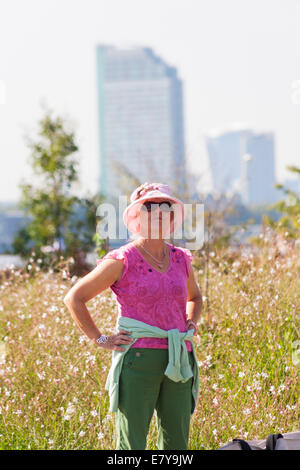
[97,45,185,201]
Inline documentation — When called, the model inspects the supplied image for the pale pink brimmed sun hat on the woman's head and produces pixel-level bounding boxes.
[123,182,185,235]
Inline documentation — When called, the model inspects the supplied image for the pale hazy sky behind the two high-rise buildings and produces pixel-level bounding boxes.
[0,0,300,201]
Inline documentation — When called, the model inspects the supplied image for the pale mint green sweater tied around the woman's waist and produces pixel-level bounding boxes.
[105,316,199,413]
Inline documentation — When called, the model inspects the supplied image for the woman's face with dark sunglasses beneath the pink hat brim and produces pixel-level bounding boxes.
[139,197,174,239]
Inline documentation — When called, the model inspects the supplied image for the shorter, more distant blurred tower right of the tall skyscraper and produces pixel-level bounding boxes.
[205,126,278,204]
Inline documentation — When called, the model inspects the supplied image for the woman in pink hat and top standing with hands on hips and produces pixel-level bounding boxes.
[64,183,202,450]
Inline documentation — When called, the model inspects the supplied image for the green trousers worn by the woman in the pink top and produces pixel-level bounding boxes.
[115,348,194,450]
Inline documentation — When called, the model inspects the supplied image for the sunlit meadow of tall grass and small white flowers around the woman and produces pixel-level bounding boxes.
[0,246,300,450]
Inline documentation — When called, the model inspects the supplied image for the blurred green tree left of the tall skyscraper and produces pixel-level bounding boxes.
[13,106,103,268]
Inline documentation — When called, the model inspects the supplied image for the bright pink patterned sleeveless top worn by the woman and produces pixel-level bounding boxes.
[97,242,194,351]
